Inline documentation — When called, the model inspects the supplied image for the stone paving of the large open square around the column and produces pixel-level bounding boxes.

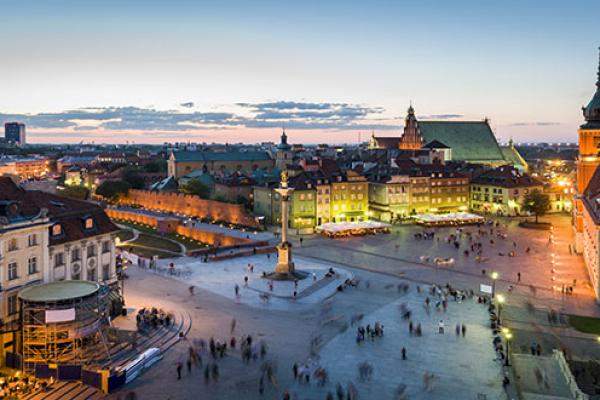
[112,216,600,400]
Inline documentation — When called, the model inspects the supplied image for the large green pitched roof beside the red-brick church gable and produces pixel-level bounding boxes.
[419,121,504,161]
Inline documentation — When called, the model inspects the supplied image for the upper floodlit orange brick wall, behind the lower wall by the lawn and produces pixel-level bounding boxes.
[121,190,260,229]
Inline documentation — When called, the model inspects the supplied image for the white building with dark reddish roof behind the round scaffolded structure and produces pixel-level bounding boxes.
[0,177,118,364]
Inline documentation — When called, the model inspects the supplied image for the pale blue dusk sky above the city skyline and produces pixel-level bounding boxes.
[0,0,600,143]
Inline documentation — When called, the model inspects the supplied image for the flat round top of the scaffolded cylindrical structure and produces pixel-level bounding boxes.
[19,281,100,303]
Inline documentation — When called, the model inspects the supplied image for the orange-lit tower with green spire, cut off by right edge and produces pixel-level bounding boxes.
[575,48,600,252]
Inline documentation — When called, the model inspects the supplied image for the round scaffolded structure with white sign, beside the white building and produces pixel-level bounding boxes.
[19,281,109,372]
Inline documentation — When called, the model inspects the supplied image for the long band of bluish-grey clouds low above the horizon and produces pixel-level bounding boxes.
[0,101,399,132]
